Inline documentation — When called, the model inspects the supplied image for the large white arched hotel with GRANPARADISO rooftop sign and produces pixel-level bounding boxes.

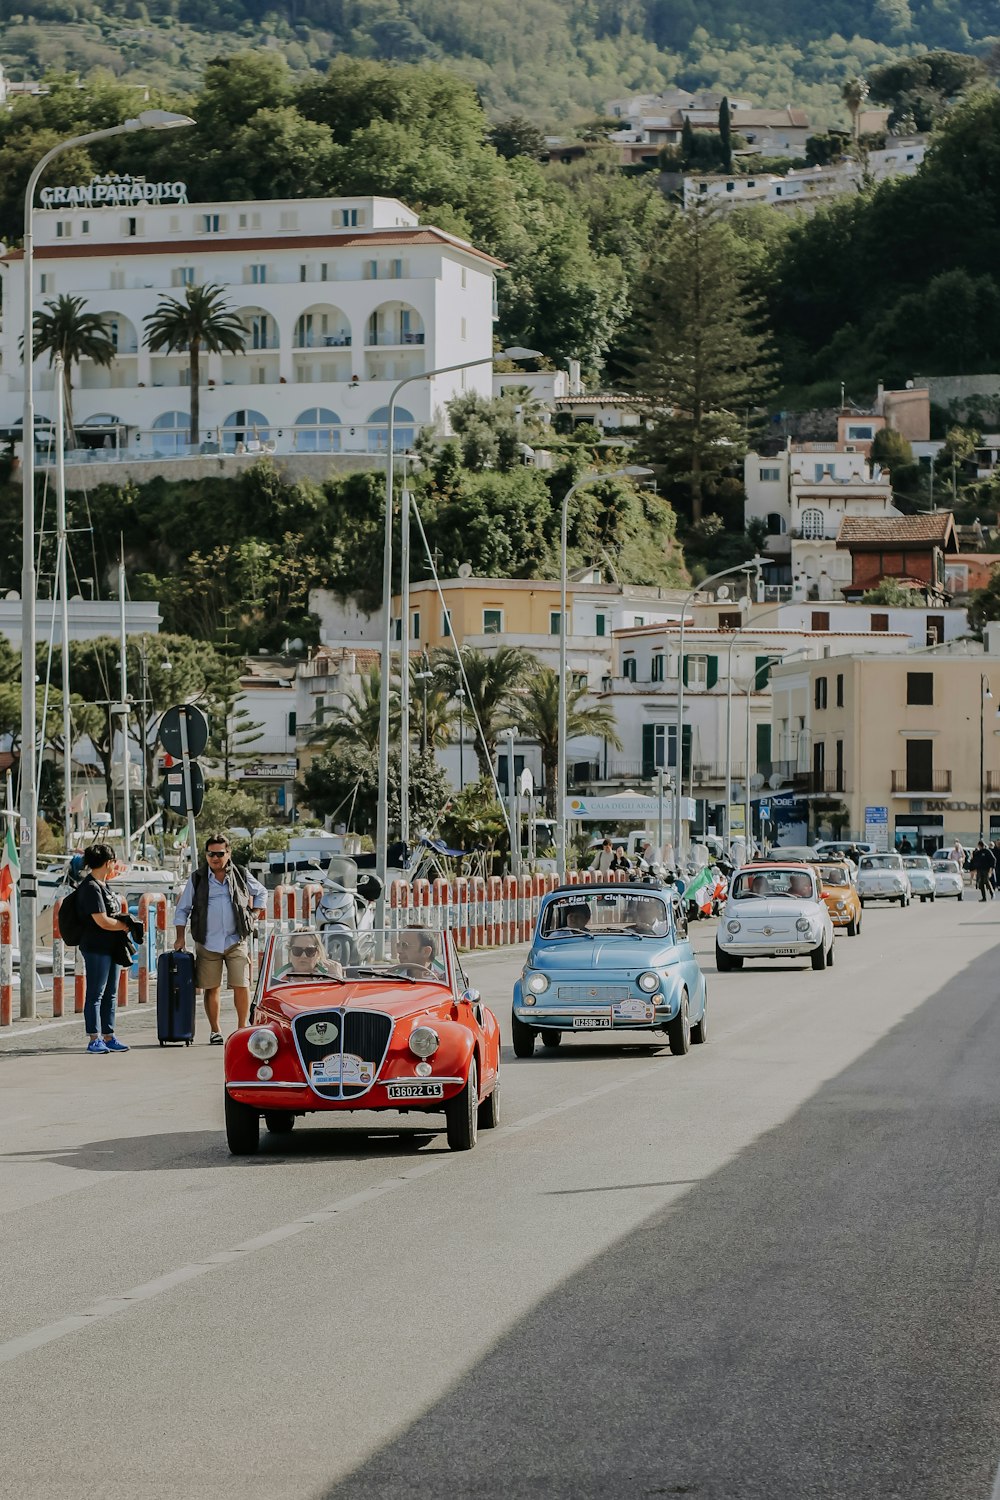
[0,185,501,458]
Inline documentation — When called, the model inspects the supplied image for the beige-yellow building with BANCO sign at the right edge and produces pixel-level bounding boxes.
[762,642,1000,849]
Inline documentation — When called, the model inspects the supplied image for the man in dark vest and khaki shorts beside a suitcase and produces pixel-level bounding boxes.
[174,834,267,1047]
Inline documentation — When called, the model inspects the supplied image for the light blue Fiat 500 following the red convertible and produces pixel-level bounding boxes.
[511,881,708,1058]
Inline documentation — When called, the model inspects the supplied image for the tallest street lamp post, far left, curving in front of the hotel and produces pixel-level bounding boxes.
[19,110,195,1017]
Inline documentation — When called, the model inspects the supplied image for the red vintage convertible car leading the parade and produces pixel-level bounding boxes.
[225,927,501,1157]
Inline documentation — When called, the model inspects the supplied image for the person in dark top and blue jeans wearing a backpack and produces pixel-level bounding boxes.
[75,845,132,1053]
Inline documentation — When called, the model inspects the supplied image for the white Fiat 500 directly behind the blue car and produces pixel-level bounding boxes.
[715,861,834,974]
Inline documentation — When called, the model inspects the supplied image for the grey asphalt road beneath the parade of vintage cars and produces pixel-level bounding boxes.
[0,902,1000,1500]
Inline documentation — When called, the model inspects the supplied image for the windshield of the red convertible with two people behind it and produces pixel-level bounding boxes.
[268,927,448,984]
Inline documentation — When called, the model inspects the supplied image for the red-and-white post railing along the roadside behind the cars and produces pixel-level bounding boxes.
[0,870,628,1028]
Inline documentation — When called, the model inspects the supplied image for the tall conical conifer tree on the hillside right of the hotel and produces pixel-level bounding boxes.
[630,207,774,522]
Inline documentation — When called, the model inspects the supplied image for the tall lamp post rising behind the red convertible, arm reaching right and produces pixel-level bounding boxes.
[375,347,540,923]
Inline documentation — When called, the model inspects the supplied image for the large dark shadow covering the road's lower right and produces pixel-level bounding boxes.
[316,951,1000,1500]
